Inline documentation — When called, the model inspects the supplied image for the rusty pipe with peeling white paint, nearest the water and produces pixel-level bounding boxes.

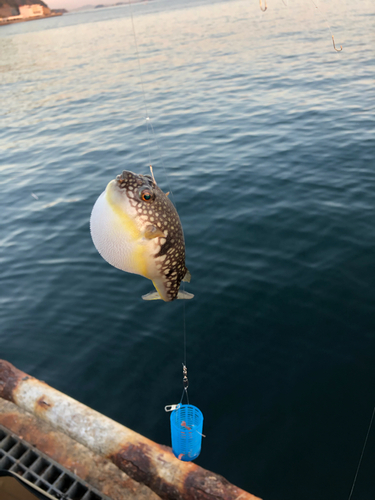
[0,360,259,500]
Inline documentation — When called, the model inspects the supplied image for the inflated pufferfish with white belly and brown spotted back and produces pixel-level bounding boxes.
[90,170,194,302]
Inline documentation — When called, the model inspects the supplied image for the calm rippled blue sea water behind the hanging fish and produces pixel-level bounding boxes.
[0,0,375,500]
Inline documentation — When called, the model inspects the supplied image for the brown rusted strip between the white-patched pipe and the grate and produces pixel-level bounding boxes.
[0,398,160,500]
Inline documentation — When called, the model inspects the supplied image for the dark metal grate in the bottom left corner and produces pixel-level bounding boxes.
[0,425,110,500]
